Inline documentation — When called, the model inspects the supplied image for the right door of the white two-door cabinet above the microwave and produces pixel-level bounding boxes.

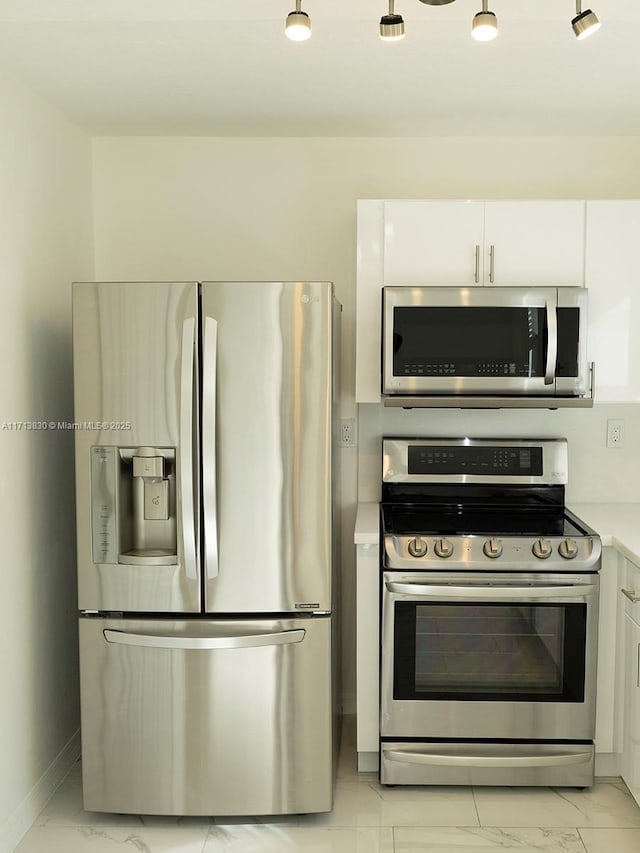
[483,201,585,287]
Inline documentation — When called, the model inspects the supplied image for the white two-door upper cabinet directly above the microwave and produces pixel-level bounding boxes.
[384,201,585,286]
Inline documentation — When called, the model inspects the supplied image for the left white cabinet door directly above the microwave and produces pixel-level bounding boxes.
[384,201,484,286]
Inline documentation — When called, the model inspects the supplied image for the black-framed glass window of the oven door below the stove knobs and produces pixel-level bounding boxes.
[393,601,587,702]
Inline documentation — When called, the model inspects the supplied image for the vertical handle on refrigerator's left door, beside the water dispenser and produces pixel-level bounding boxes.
[179,317,198,580]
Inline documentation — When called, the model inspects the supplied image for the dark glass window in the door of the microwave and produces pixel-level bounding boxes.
[393,306,547,377]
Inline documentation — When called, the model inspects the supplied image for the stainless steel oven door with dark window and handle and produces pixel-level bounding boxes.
[381,572,599,740]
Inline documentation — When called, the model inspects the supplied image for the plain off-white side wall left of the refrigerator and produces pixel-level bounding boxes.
[0,65,93,851]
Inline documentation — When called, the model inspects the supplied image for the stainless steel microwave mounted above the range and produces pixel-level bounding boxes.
[382,287,590,398]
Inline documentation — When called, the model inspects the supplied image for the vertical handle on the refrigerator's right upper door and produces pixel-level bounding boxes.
[202,317,219,578]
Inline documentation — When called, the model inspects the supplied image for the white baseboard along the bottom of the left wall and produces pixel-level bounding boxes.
[0,729,80,853]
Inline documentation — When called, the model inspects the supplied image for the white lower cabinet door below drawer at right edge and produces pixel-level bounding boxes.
[621,605,640,803]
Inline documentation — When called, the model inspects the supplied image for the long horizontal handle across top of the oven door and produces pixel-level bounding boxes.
[385,581,596,601]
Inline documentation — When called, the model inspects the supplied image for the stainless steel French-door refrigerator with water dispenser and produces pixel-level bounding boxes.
[73,282,340,815]
